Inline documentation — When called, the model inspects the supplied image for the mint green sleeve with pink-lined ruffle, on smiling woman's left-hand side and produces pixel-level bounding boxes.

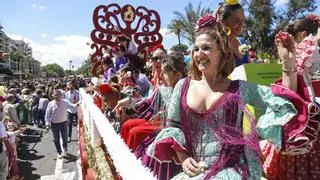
[147,79,186,162]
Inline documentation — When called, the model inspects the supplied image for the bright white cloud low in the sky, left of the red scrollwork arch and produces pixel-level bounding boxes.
[8,34,92,69]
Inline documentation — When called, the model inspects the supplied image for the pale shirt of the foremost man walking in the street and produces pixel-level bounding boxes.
[45,99,75,125]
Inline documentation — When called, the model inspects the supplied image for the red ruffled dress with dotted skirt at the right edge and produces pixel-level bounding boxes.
[264,75,320,180]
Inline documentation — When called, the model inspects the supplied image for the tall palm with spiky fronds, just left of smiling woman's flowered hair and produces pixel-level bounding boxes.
[173,2,212,44]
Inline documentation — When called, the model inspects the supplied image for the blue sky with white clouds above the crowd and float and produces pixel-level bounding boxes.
[0,0,320,68]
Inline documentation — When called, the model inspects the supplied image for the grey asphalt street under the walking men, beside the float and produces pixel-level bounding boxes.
[17,126,81,180]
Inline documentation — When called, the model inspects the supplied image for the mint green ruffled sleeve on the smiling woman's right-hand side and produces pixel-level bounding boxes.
[240,81,297,149]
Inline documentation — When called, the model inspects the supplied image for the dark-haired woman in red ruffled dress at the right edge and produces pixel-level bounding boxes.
[262,14,320,180]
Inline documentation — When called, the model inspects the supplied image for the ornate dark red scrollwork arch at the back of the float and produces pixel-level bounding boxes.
[90,3,162,76]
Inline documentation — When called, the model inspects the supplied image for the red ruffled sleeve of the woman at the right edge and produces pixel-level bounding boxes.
[271,74,320,155]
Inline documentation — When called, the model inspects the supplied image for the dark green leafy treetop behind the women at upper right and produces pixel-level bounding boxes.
[243,0,317,54]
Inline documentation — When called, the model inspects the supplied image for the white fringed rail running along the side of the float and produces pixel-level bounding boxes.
[80,89,156,180]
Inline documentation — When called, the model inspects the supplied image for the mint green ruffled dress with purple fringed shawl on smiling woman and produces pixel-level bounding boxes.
[147,78,296,180]
